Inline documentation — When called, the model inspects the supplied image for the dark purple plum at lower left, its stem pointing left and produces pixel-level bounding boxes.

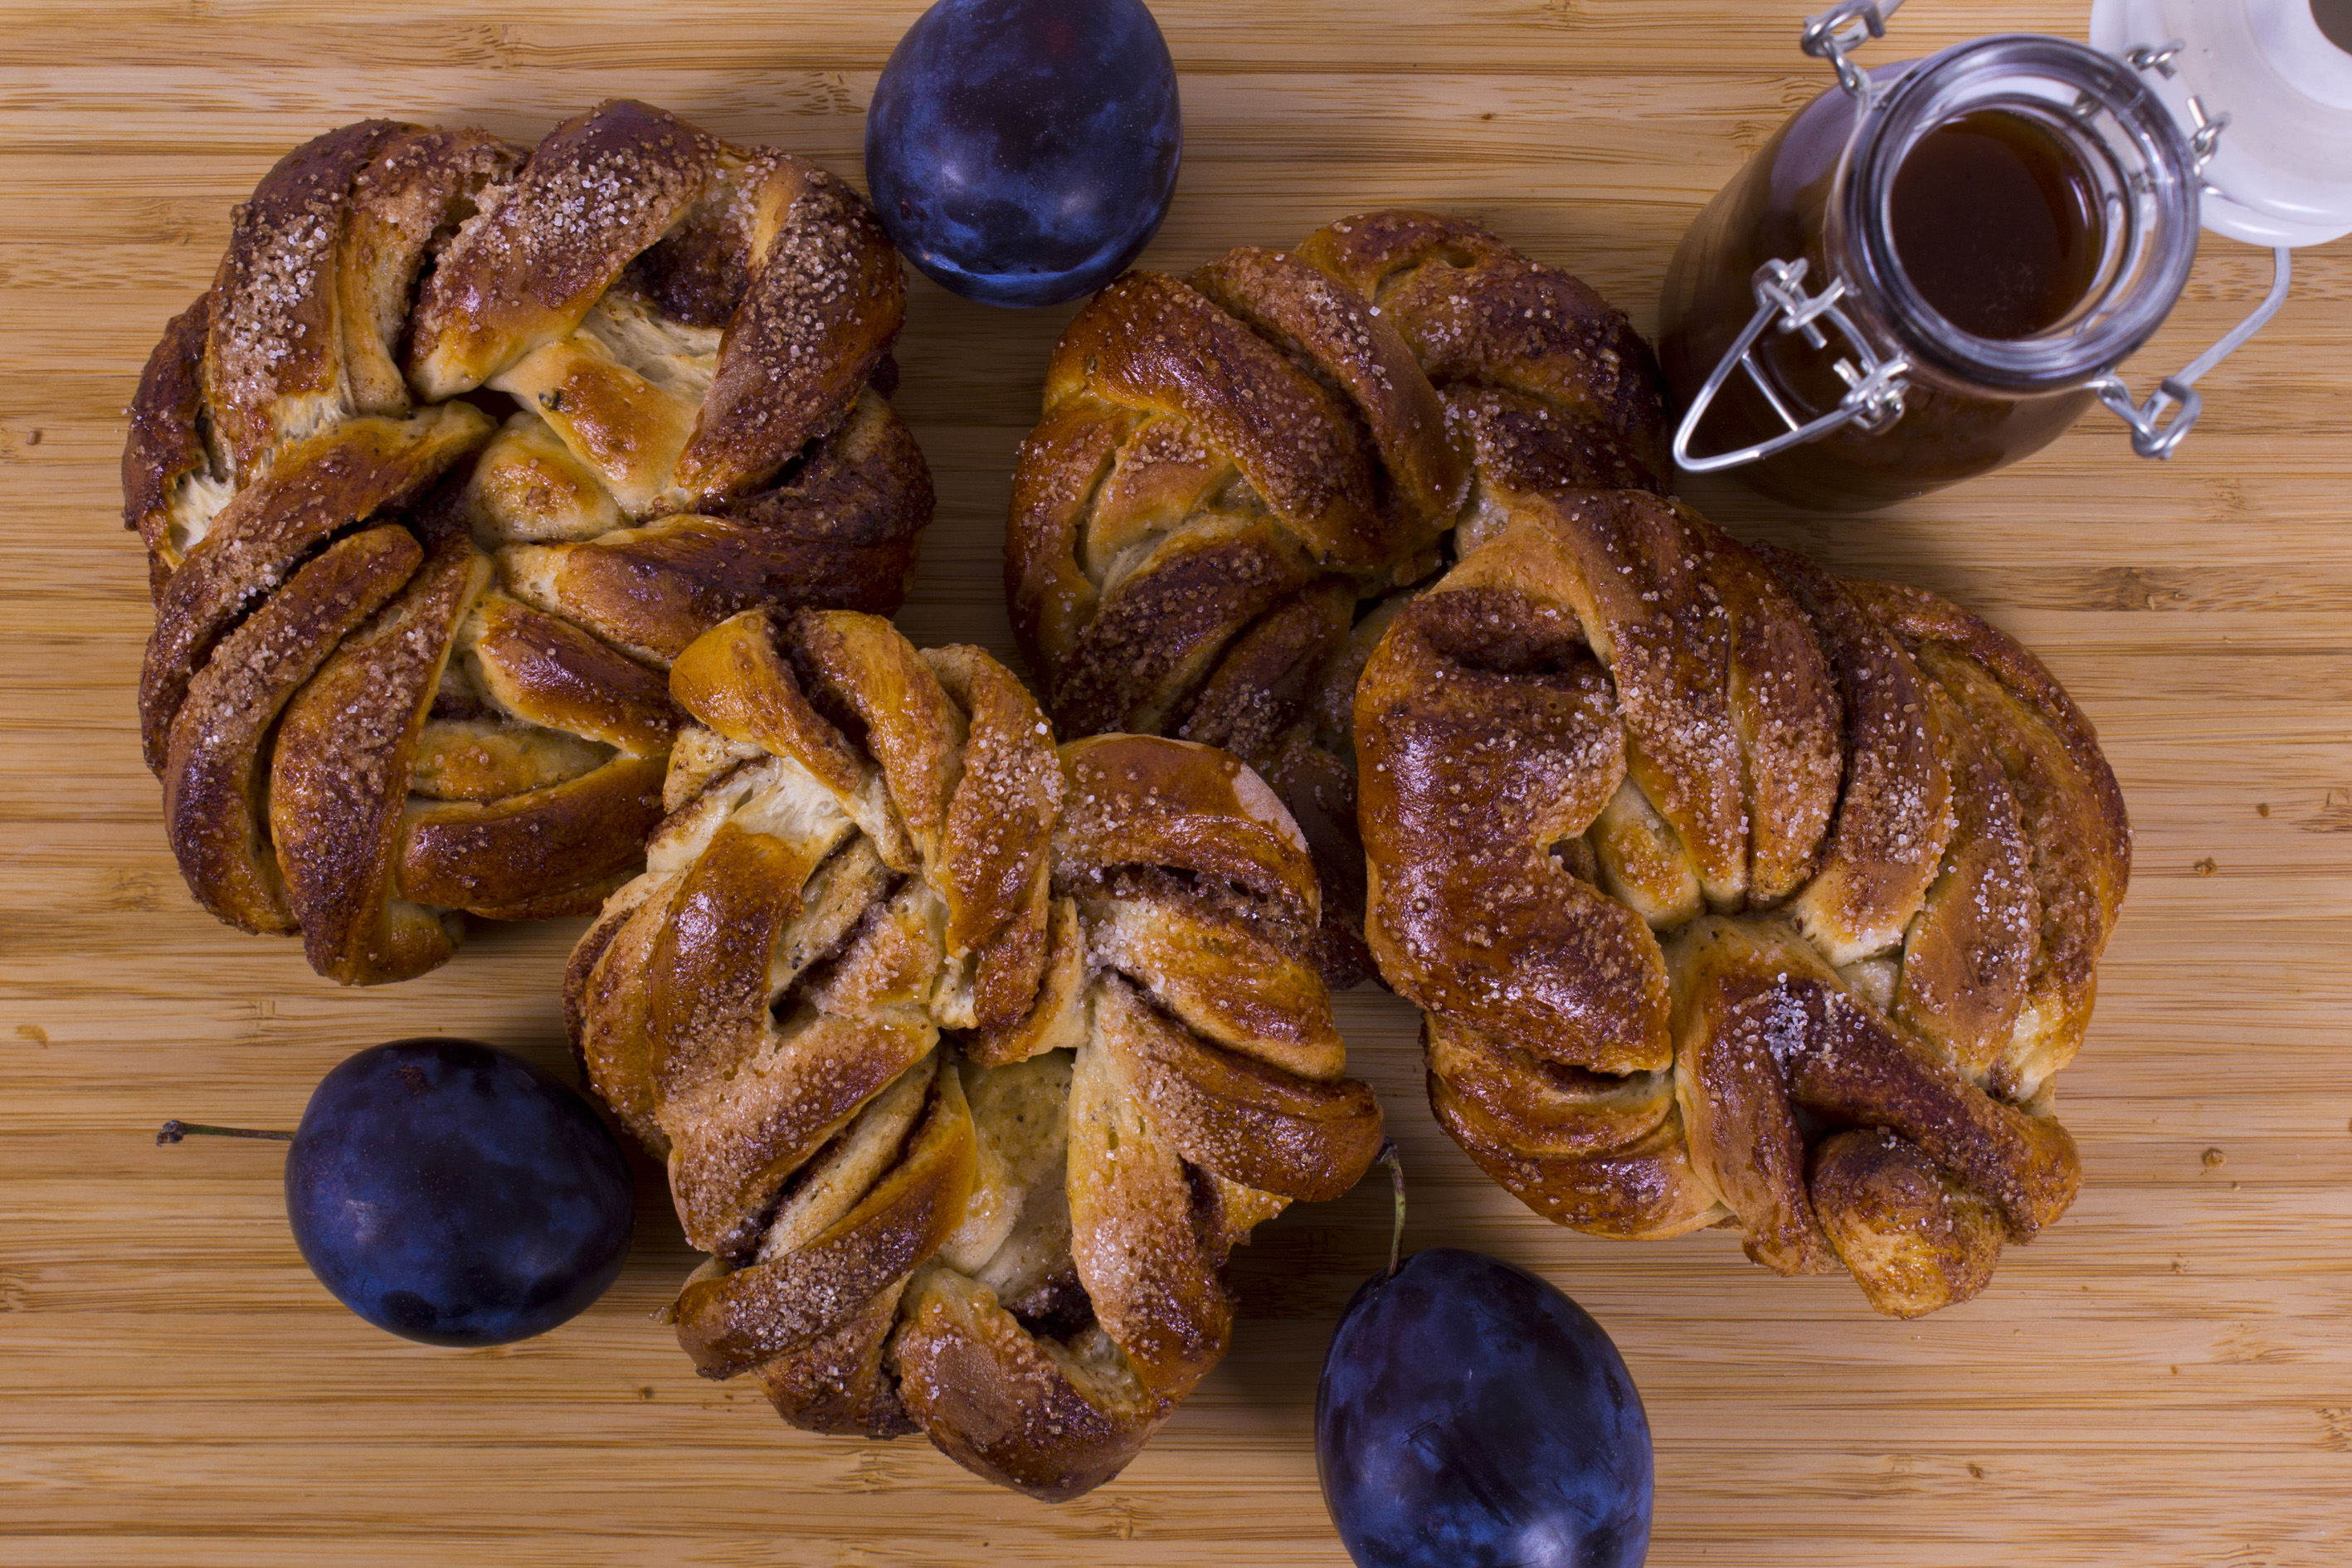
[287,1039,637,1345]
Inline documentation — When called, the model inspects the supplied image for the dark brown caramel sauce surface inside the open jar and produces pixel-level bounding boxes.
[1887,108,2105,338]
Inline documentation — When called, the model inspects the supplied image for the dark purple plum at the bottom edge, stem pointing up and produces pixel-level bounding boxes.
[1315,1246,1651,1568]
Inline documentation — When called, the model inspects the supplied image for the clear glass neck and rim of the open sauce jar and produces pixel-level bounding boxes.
[1823,33,2199,395]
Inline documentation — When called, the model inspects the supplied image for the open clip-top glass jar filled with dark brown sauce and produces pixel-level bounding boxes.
[1658,20,2201,510]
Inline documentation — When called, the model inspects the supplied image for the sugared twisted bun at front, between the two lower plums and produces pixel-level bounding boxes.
[564,611,1381,1500]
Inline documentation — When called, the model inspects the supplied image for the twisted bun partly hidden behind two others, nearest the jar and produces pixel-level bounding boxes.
[1005,212,1665,982]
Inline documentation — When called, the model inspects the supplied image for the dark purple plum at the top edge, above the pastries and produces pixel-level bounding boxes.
[865,0,1183,305]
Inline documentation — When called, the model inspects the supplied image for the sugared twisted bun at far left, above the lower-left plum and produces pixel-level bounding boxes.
[122,101,932,982]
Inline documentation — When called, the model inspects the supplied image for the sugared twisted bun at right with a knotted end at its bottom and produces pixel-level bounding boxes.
[1355,489,2131,1317]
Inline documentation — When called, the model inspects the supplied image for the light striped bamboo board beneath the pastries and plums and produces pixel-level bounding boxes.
[0,0,2352,1568]
